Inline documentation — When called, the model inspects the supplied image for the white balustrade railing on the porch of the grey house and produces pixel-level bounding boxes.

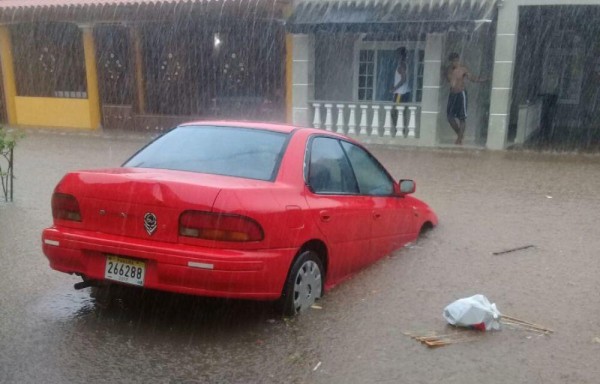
[309,101,421,139]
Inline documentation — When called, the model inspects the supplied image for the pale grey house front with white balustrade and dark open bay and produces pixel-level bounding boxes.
[288,0,600,150]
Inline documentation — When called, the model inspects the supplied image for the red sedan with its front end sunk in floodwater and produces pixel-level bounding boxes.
[42,122,437,315]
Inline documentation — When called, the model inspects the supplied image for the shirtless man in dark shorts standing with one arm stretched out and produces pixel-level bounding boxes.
[446,52,487,145]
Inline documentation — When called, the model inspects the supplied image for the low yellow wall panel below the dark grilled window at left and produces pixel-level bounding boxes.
[15,96,96,129]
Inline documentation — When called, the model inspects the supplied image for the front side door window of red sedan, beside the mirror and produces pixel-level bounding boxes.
[342,141,394,196]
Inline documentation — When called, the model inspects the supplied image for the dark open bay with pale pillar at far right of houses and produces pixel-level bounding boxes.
[504,0,600,151]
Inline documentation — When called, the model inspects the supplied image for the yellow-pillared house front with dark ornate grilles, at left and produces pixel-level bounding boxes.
[0,0,289,131]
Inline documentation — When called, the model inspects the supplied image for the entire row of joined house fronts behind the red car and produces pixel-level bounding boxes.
[0,0,600,150]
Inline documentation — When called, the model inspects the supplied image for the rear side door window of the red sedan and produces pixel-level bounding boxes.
[307,137,358,194]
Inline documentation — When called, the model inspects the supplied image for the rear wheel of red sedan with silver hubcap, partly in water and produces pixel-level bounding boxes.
[279,251,323,316]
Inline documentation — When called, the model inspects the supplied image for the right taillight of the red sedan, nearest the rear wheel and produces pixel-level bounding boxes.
[179,211,264,241]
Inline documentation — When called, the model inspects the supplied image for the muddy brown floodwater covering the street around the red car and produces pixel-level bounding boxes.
[0,130,600,384]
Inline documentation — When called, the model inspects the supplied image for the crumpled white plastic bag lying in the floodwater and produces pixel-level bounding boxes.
[443,295,502,331]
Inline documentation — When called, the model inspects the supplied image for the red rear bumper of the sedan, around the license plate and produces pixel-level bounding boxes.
[42,227,297,300]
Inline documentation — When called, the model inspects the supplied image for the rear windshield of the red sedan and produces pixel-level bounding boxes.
[123,126,288,180]
